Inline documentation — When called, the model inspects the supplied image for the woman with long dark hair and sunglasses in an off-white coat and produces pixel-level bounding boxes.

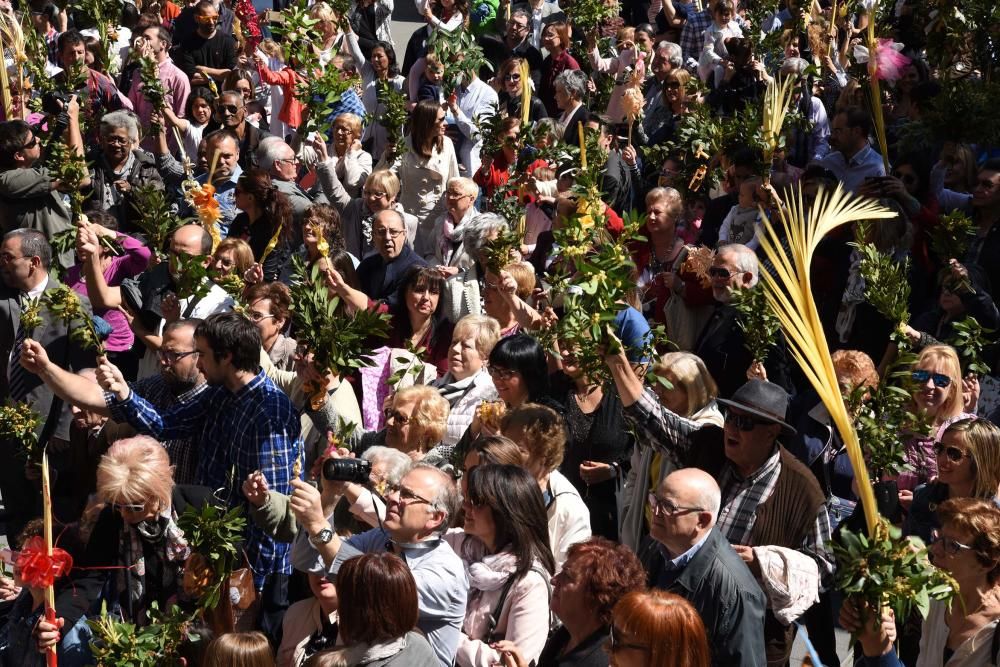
[379,100,459,258]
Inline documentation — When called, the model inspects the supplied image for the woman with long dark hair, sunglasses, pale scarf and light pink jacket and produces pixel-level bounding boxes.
[447,465,555,667]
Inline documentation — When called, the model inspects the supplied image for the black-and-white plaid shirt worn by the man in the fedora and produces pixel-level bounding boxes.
[625,389,835,581]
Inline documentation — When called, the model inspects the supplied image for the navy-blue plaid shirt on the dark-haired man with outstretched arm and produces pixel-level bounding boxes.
[109,372,302,590]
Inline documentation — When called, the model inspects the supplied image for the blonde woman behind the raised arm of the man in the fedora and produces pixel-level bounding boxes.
[619,352,722,551]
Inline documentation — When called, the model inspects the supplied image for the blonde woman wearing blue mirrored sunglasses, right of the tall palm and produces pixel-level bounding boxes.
[896,345,971,498]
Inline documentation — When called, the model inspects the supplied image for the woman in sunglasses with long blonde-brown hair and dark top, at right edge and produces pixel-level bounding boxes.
[903,417,1000,541]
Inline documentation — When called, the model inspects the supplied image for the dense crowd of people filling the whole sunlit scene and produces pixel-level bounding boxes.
[0,0,1000,667]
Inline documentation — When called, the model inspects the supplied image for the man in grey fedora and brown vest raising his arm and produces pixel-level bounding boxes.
[606,354,834,667]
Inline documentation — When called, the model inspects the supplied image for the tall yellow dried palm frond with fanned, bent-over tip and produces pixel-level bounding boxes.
[761,185,896,533]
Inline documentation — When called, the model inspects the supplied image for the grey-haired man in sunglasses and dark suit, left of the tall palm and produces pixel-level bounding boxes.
[692,243,794,398]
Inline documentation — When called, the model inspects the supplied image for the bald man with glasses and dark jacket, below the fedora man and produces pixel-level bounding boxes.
[648,468,767,667]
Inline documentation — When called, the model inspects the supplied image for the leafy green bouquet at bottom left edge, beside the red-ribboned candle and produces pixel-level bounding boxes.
[87,602,198,667]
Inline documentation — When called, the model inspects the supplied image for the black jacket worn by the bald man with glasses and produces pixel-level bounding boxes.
[646,528,767,667]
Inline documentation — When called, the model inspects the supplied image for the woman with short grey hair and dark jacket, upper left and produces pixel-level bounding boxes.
[87,111,164,232]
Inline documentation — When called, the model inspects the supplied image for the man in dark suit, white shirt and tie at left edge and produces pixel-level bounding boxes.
[0,229,96,537]
